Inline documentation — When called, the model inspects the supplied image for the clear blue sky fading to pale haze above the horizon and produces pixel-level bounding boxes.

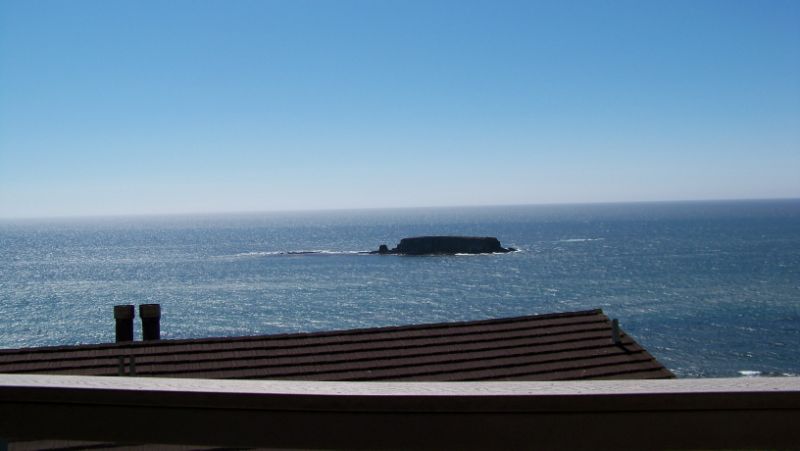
[0,0,800,218]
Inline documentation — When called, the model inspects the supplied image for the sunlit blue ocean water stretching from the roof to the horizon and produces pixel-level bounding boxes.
[0,200,800,377]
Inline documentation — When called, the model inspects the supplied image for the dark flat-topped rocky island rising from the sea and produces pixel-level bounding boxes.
[372,236,516,255]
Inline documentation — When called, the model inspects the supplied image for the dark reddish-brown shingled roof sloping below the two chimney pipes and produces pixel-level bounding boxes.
[0,310,674,381]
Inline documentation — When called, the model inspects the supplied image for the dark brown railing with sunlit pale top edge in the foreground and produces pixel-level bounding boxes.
[0,375,800,449]
